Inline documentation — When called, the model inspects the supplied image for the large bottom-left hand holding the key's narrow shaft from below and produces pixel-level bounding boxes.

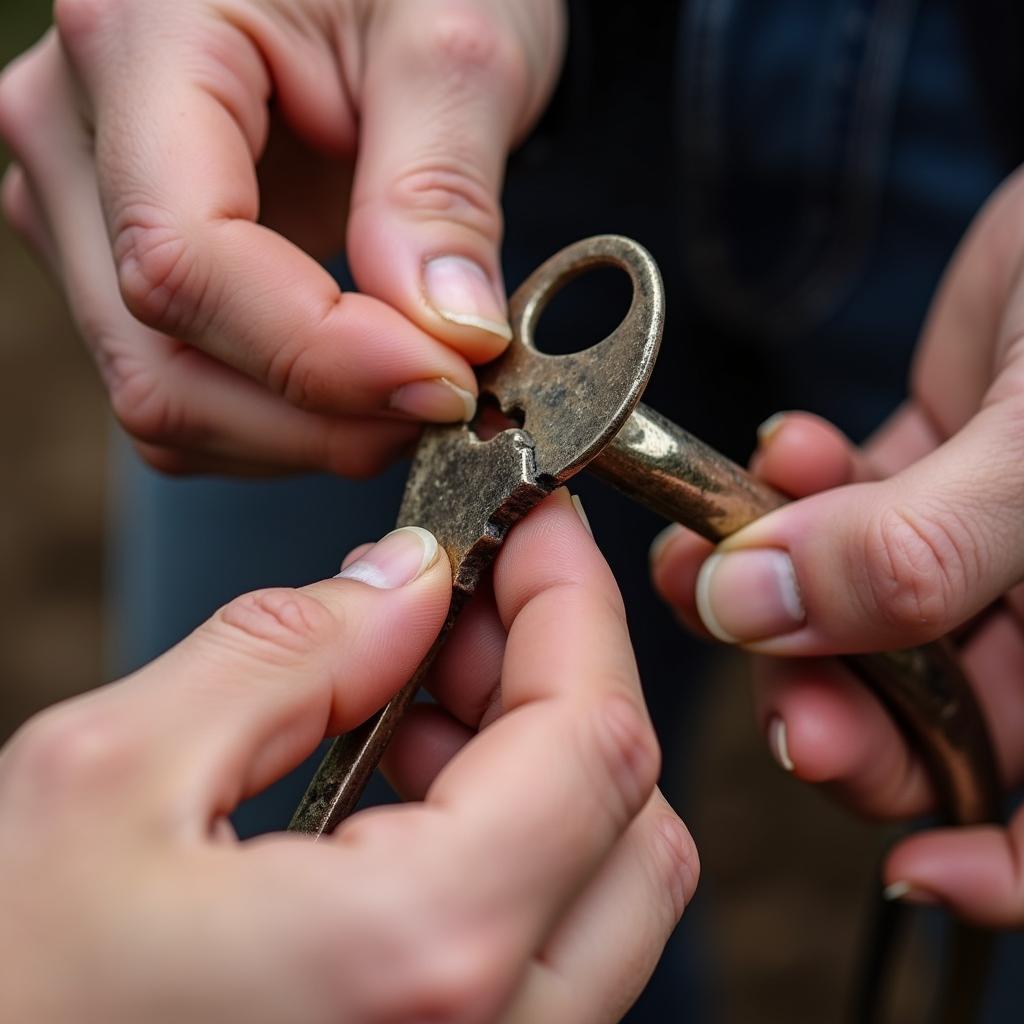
[0,493,697,1024]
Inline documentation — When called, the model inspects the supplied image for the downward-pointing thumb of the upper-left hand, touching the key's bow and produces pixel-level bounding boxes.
[348,0,561,368]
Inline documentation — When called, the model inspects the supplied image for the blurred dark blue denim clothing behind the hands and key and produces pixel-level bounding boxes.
[112,0,1017,1022]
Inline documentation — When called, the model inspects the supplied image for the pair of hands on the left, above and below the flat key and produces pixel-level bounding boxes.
[0,6,698,1022]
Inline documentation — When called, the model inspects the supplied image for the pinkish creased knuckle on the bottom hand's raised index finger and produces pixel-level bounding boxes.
[585,694,662,826]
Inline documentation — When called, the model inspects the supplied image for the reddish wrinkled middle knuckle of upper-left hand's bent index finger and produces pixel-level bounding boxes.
[114,211,206,334]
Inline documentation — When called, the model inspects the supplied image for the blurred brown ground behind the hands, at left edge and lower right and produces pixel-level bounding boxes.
[0,0,937,1024]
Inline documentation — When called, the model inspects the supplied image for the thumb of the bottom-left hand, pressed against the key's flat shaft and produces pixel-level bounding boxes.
[76,528,451,827]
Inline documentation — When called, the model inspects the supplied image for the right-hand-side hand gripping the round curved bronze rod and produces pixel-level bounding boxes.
[654,172,1024,927]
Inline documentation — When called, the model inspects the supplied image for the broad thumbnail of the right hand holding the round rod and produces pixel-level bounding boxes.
[696,548,806,643]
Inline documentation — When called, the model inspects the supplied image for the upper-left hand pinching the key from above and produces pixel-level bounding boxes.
[0,0,564,476]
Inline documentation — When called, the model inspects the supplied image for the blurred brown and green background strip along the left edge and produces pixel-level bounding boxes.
[0,0,108,736]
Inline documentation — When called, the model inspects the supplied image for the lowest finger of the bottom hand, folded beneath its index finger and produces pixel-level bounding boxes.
[502,794,700,1024]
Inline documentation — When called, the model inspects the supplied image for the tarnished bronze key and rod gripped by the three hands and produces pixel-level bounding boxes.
[291,236,999,835]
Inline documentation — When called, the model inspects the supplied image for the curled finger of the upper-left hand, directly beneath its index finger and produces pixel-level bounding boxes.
[6,35,415,476]
